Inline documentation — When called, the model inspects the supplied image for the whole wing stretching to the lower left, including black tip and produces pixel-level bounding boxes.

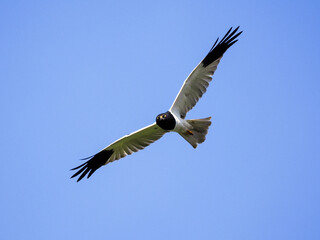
[71,123,168,182]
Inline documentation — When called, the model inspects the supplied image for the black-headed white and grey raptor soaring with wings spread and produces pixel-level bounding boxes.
[71,26,242,182]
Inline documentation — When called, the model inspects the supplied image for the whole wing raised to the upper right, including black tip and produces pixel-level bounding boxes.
[170,27,242,118]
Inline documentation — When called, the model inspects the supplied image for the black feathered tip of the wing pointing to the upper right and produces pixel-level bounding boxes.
[202,26,242,67]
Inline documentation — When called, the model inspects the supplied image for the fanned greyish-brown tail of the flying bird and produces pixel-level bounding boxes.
[180,117,211,148]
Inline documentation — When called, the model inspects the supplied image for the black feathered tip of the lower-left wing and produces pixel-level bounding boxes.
[70,150,113,182]
